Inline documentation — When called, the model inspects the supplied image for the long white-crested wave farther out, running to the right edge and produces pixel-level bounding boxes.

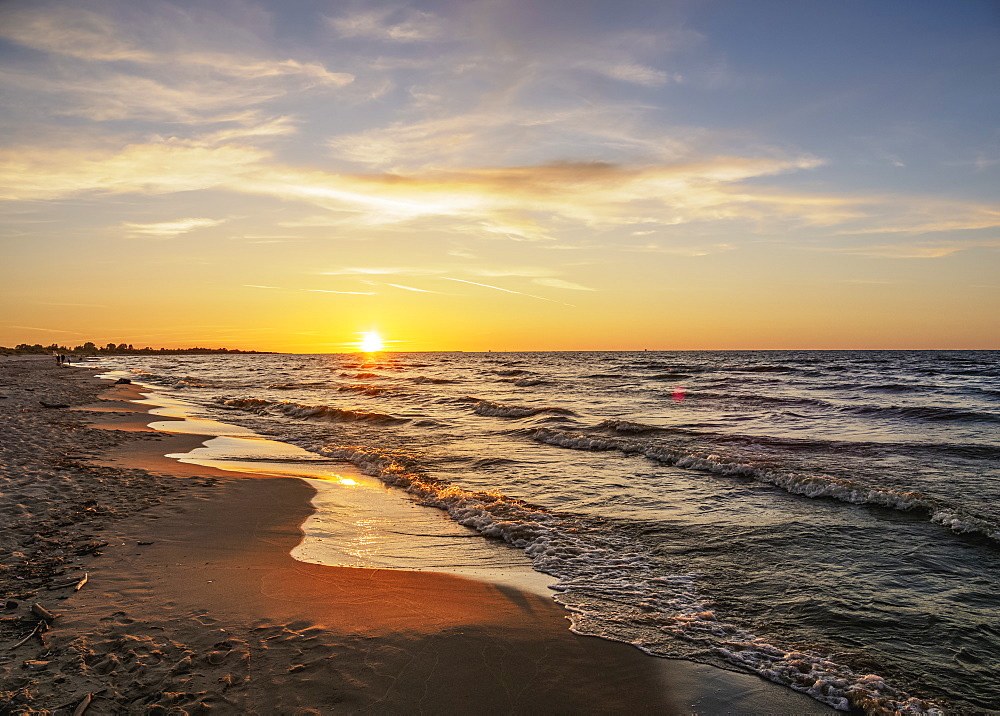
[529,427,1000,543]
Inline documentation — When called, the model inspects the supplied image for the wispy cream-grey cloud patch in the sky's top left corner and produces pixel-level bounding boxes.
[0,3,354,123]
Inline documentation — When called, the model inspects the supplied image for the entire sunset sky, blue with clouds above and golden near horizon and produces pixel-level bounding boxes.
[0,0,1000,353]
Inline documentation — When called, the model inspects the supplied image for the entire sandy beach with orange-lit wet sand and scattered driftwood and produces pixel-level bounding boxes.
[0,358,830,714]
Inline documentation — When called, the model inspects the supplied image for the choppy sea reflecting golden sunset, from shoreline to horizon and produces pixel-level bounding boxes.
[88,351,1000,713]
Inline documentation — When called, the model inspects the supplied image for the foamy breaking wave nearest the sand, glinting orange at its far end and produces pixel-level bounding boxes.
[310,445,941,715]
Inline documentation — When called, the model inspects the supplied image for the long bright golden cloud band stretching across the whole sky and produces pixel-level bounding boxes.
[0,127,984,250]
